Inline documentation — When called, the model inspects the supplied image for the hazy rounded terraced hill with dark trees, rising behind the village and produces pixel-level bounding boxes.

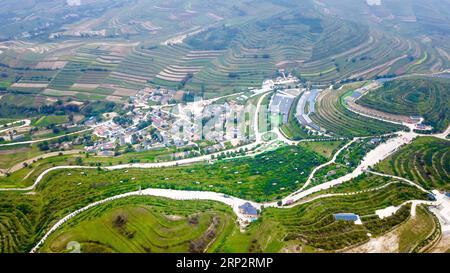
[186,12,413,94]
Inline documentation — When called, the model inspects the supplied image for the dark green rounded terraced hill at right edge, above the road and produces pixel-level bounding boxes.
[358,78,450,131]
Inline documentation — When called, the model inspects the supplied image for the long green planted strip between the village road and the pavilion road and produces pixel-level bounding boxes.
[37,147,324,201]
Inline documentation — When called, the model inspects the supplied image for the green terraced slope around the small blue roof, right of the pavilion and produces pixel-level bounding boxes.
[219,176,427,252]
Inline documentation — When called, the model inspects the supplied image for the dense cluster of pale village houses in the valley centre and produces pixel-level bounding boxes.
[85,85,253,158]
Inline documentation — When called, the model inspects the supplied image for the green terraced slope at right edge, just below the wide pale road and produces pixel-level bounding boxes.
[376,137,450,191]
